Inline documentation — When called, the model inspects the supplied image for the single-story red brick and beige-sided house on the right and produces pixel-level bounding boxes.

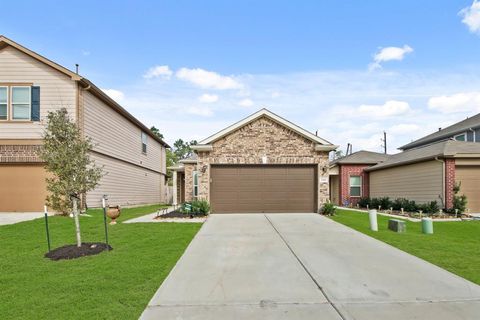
[330,140,480,213]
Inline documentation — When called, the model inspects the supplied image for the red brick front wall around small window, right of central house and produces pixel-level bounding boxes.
[338,164,370,206]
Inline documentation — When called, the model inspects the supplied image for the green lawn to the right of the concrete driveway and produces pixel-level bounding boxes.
[332,209,480,284]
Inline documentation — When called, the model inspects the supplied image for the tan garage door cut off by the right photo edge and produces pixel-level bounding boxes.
[455,166,480,213]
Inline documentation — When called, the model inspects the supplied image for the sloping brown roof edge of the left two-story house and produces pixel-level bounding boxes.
[0,35,170,148]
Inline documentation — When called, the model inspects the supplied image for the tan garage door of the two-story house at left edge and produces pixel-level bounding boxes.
[0,165,47,212]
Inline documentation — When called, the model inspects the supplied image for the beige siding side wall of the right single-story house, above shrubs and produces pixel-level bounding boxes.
[370,160,444,203]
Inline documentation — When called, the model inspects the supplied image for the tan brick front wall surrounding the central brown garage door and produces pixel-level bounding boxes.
[185,117,329,208]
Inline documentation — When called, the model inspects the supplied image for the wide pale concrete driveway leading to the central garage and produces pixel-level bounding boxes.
[141,214,480,320]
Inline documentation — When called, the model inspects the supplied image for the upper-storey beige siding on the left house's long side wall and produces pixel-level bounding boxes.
[82,91,166,173]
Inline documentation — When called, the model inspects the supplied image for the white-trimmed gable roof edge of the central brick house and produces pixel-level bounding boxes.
[195,108,338,150]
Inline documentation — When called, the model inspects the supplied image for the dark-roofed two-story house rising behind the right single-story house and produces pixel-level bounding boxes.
[398,113,480,151]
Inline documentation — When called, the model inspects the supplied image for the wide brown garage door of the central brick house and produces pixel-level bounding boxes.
[210,165,316,213]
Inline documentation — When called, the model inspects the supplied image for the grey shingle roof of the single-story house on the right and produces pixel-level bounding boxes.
[365,140,480,171]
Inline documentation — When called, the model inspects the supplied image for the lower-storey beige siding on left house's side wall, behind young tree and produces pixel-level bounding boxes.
[87,153,165,207]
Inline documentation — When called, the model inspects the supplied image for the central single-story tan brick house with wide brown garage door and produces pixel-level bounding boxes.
[171,109,337,213]
